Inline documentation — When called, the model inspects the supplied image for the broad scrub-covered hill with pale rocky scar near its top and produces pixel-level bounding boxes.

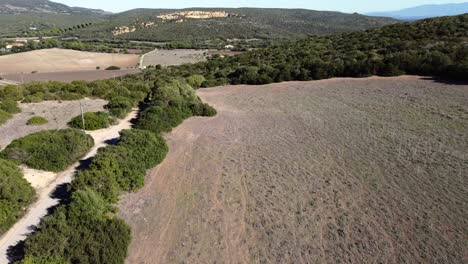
[69,8,398,41]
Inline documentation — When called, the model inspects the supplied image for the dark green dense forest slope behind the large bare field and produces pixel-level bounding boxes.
[137,15,468,87]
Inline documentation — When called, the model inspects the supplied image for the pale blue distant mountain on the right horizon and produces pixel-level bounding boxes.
[366,2,468,20]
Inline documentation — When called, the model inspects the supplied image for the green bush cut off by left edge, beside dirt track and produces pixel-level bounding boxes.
[0,159,35,235]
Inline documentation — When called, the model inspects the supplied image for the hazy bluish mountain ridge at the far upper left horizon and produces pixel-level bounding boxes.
[0,0,109,15]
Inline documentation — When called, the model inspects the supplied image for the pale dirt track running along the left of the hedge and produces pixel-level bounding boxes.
[0,110,138,264]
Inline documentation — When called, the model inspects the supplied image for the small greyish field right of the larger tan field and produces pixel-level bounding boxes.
[141,49,208,67]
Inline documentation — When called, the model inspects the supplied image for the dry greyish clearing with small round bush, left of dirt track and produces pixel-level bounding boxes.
[0,99,107,149]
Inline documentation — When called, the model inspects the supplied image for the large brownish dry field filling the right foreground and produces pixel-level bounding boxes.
[120,77,468,263]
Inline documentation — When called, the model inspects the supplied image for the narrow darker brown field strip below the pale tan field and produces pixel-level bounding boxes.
[4,69,141,83]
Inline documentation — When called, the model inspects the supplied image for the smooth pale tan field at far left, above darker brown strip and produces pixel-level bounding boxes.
[0,49,140,74]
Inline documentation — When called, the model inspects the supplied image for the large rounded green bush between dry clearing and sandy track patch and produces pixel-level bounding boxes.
[1,129,94,172]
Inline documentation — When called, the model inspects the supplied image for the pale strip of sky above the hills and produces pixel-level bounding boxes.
[52,0,467,13]
